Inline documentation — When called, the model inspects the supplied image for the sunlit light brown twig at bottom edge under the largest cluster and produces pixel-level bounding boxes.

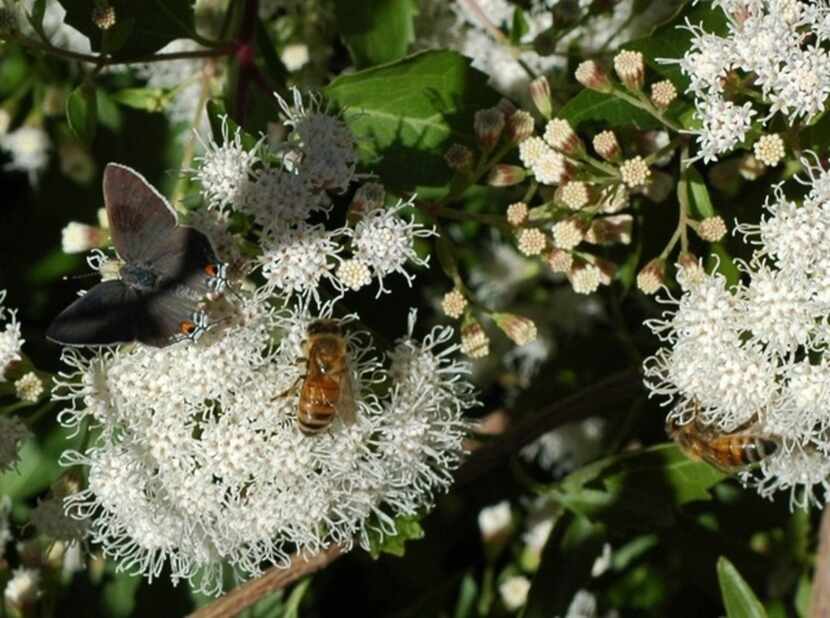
[190,545,343,618]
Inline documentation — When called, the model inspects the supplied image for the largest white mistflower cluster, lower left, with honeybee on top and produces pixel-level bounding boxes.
[54,294,474,594]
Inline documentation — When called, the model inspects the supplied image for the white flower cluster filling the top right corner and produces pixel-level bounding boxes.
[667,0,830,162]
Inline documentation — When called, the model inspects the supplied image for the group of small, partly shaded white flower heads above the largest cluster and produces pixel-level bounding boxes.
[191,90,435,301]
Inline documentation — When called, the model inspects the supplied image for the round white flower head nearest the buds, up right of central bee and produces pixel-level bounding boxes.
[347,198,435,295]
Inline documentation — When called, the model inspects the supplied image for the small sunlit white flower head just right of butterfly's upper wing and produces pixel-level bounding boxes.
[189,116,262,210]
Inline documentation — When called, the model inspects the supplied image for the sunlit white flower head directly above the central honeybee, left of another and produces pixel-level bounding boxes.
[259,223,342,299]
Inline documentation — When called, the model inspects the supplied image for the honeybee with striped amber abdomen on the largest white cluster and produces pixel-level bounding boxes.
[297,320,355,435]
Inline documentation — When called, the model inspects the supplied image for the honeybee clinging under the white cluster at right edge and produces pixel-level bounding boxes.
[666,417,781,474]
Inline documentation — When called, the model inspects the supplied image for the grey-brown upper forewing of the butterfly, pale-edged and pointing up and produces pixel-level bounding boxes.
[104,163,177,262]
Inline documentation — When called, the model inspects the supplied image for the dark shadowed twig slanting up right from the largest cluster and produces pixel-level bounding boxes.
[455,369,644,484]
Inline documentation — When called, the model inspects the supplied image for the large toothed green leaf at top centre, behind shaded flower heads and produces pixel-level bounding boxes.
[325,50,499,192]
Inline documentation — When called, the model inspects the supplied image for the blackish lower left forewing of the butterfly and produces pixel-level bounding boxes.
[46,281,145,346]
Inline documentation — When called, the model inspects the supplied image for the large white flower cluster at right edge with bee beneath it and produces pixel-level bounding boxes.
[645,154,830,507]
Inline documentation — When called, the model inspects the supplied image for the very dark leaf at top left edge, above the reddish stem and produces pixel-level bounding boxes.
[59,0,194,59]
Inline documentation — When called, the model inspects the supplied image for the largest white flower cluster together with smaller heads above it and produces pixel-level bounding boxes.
[53,94,476,594]
